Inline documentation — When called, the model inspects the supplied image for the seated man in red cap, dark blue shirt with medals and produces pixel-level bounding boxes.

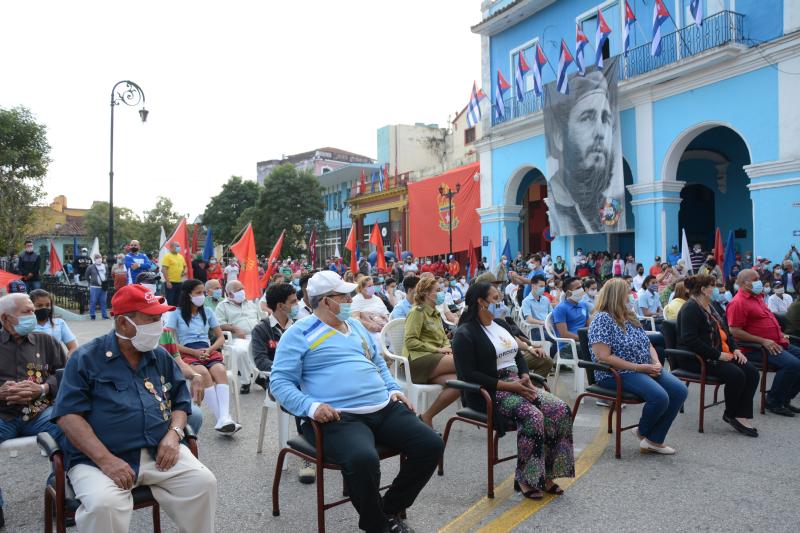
[52,285,217,533]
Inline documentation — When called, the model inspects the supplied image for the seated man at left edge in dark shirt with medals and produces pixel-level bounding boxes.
[0,293,66,525]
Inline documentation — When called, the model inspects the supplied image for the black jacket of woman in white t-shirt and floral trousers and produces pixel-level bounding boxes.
[452,320,528,435]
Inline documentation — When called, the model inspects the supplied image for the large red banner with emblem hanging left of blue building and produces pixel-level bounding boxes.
[408,163,481,257]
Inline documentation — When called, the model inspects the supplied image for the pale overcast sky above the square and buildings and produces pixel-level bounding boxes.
[0,0,480,219]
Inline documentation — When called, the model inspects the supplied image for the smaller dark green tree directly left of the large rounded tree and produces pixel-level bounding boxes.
[203,176,260,245]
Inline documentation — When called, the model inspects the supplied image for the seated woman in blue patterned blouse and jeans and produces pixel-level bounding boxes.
[589,278,687,455]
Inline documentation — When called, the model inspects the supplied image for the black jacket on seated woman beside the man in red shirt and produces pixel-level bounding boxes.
[678,299,736,362]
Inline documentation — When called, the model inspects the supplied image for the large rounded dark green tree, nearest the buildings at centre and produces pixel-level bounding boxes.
[237,164,325,257]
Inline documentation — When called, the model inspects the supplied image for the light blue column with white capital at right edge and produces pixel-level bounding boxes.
[744,159,800,262]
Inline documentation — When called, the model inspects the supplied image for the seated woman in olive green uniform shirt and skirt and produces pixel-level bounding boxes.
[403,278,459,427]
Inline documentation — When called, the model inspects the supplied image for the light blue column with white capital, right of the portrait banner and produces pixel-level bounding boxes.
[628,181,685,264]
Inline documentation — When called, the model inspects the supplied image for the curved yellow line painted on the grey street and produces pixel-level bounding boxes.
[476,416,610,533]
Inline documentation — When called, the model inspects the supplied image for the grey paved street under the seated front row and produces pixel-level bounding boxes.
[0,321,800,533]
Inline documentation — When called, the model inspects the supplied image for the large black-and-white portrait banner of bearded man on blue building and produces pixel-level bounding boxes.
[544,58,627,236]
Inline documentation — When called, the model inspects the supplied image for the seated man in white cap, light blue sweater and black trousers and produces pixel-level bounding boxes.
[270,270,443,532]
